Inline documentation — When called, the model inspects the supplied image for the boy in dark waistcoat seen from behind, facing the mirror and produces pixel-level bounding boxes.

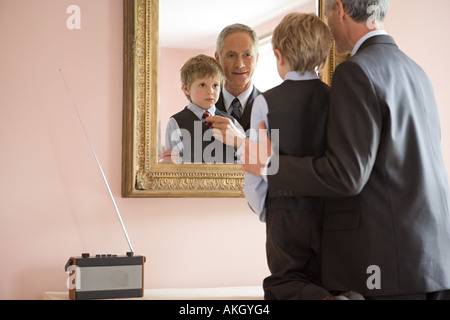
[244,13,336,300]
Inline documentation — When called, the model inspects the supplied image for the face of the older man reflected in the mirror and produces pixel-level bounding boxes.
[216,32,258,96]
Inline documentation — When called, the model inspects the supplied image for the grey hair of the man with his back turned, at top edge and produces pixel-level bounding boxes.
[326,0,389,23]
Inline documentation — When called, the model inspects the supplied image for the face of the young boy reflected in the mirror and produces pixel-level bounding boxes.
[183,77,220,110]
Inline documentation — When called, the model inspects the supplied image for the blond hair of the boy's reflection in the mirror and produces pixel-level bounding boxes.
[180,54,224,102]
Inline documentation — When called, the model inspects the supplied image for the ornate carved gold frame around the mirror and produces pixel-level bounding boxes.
[122,0,336,198]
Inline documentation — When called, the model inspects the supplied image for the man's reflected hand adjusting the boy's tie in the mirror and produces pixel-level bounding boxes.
[205,116,245,149]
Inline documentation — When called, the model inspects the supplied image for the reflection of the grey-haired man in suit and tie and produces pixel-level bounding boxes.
[208,24,260,135]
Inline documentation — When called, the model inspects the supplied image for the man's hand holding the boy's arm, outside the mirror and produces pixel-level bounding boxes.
[241,121,274,176]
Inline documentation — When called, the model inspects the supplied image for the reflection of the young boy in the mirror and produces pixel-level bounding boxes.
[165,54,241,163]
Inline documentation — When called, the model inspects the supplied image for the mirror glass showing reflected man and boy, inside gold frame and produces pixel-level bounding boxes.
[158,0,316,164]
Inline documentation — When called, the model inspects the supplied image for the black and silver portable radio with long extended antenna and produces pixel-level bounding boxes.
[59,69,145,300]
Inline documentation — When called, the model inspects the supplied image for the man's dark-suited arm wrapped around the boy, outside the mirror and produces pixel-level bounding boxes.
[244,63,382,197]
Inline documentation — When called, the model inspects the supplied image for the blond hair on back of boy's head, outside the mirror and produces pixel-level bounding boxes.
[272,13,332,74]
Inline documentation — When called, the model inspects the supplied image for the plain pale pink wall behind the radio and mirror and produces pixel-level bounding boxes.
[0,0,450,299]
